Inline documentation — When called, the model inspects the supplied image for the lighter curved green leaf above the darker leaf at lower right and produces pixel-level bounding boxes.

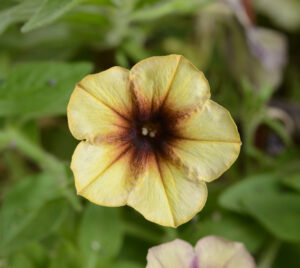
[219,173,280,213]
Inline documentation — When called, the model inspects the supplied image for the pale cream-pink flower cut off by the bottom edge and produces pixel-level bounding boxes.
[146,236,256,268]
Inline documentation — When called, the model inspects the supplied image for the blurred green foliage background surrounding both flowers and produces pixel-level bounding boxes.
[0,0,300,268]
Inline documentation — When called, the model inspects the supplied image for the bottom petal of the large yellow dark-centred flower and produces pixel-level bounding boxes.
[128,155,207,227]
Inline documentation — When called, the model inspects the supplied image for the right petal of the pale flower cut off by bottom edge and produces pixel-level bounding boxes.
[196,236,255,268]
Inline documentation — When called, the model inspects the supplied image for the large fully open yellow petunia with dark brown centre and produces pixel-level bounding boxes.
[68,55,241,227]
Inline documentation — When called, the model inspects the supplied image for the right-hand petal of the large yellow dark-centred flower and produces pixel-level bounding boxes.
[170,100,241,182]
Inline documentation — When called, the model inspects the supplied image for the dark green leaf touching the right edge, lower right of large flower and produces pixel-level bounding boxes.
[244,194,300,242]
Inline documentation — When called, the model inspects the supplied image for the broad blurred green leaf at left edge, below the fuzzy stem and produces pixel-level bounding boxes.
[0,174,67,254]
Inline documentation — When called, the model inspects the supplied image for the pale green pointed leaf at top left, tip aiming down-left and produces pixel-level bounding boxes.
[21,0,81,33]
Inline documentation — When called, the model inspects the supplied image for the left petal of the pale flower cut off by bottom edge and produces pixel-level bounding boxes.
[146,239,195,268]
